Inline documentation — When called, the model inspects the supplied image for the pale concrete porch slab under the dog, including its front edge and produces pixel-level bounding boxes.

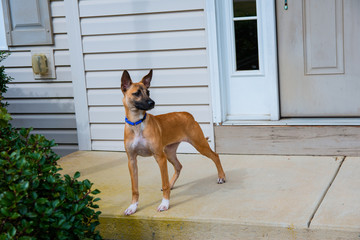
[59,151,360,240]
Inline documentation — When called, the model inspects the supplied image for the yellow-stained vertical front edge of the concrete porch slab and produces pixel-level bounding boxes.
[98,216,359,240]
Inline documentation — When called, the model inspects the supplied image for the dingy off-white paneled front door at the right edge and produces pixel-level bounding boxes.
[276,0,360,117]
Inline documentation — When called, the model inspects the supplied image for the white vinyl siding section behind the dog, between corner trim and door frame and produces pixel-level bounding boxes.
[79,0,214,152]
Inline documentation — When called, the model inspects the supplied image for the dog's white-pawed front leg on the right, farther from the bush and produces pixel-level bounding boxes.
[155,152,170,212]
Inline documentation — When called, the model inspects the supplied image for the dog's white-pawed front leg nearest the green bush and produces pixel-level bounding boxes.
[124,155,139,215]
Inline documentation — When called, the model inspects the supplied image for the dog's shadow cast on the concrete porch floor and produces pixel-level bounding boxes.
[139,169,247,210]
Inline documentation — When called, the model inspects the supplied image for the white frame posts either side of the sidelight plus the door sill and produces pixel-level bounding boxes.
[205,0,360,126]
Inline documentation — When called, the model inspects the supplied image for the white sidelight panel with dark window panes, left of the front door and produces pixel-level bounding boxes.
[215,0,279,124]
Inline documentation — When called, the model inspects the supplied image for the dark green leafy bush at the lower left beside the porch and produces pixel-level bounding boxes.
[0,52,101,240]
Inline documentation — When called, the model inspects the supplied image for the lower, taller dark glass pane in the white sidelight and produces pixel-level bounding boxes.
[234,20,259,71]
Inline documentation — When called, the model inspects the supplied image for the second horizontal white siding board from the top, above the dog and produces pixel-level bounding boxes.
[81,10,206,35]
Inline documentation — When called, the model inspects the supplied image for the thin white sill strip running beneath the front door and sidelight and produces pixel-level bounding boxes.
[222,118,360,126]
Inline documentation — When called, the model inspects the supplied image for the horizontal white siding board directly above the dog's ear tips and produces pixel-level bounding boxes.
[84,50,207,71]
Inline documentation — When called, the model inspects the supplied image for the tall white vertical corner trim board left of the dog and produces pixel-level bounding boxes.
[64,0,91,150]
